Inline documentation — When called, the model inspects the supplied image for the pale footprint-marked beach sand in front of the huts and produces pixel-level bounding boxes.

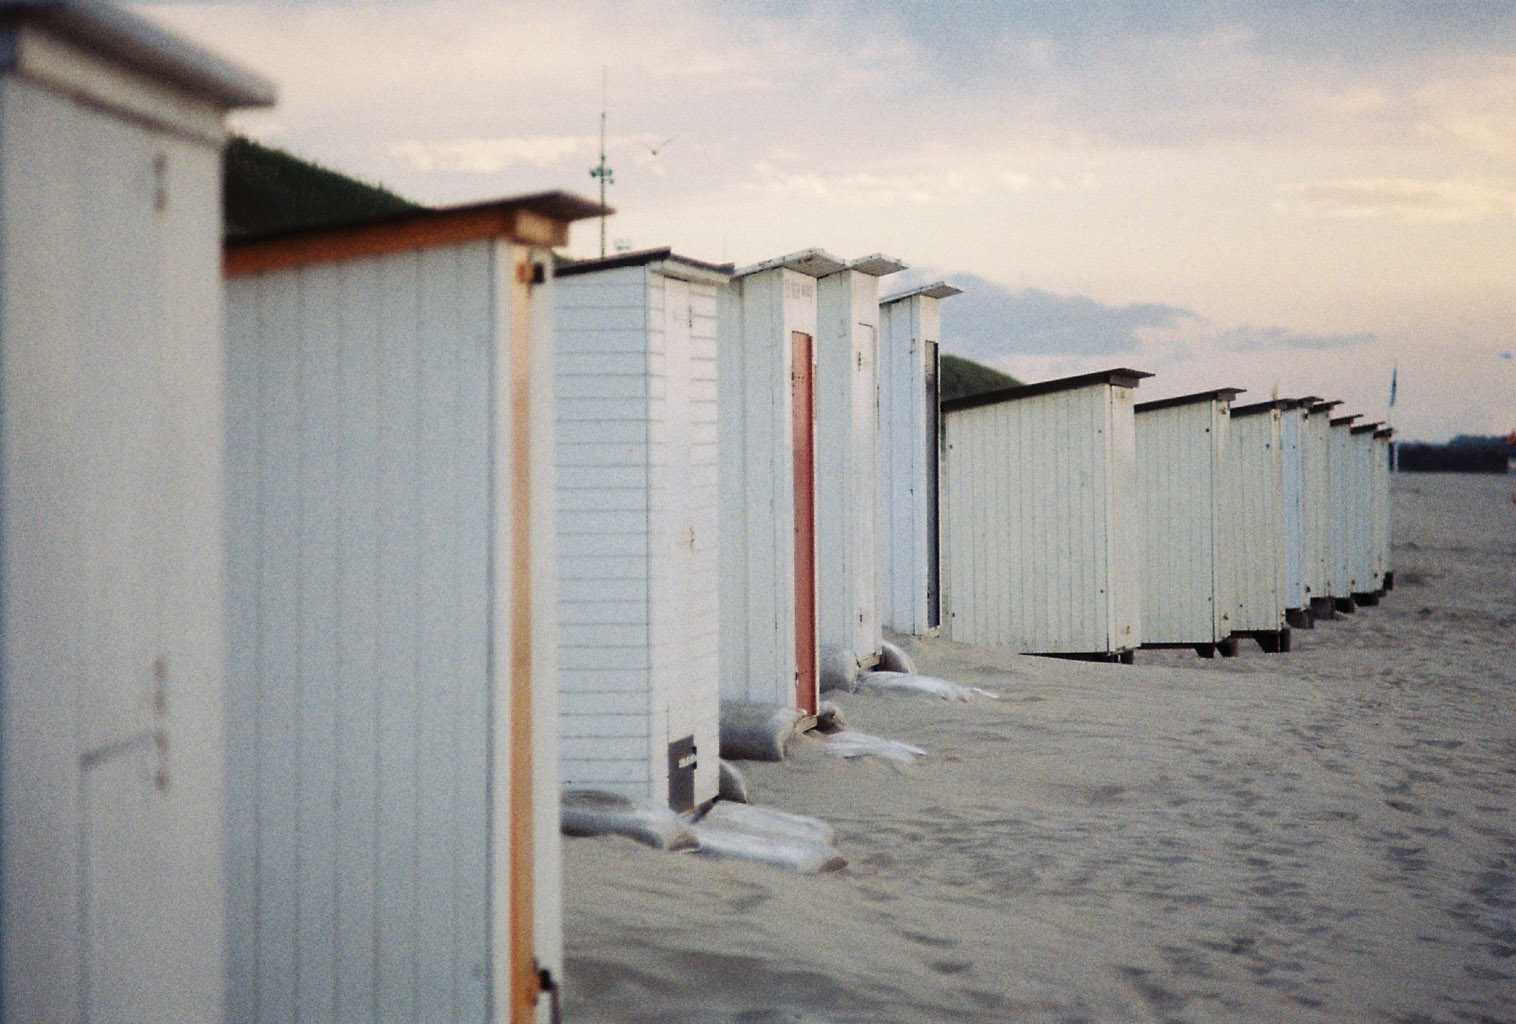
[564,475,1516,1024]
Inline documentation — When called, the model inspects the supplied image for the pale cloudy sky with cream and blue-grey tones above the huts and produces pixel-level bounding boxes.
[133,0,1516,440]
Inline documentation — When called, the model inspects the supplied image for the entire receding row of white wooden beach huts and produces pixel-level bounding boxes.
[0,0,1393,1022]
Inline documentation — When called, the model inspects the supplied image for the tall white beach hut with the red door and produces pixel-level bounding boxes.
[717,249,843,715]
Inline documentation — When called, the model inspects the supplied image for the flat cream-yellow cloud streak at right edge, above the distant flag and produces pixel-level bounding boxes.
[1278,177,1516,221]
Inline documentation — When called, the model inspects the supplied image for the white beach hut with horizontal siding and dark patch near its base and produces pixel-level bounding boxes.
[553,249,731,810]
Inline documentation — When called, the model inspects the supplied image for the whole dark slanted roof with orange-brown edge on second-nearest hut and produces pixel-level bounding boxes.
[223,191,609,278]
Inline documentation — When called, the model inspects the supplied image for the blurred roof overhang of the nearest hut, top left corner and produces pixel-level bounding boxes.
[0,0,276,111]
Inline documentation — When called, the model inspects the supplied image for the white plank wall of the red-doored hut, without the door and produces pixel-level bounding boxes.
[717,267,816,707]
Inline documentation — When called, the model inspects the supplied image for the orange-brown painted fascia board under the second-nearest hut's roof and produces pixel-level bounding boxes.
[221,203,569,278]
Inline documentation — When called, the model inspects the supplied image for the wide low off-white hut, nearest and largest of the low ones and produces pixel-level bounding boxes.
[943,369,1151,661]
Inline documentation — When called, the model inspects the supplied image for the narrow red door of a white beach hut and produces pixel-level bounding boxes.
[790,331,817,715]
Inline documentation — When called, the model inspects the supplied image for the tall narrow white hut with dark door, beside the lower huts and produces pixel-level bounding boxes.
[879,281,963,636]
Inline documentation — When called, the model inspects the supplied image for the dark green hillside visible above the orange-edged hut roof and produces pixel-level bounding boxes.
[221,135,420,238]
